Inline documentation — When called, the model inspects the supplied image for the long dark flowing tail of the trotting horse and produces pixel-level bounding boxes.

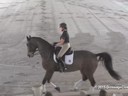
[96,52,121,80]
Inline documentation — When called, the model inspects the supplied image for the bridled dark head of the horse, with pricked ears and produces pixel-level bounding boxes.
[26,36,37,57]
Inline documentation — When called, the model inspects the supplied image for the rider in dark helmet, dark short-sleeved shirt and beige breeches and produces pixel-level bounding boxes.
[56,23,70,72]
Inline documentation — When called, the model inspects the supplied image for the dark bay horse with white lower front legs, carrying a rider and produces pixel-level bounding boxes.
[27,36,121,91]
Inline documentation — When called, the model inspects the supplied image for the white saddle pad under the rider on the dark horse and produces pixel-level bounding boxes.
[53,53,74,65]
